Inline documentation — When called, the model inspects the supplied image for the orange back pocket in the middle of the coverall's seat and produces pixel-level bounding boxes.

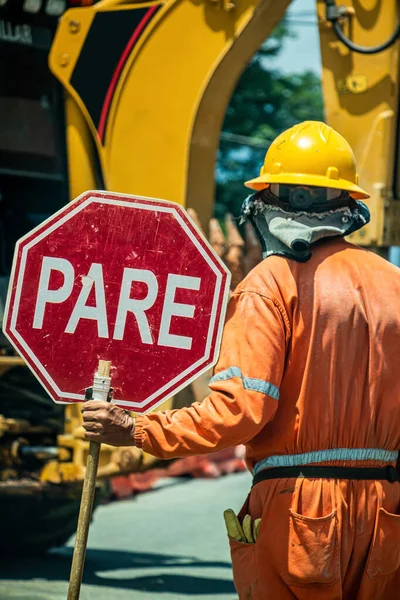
[282,509,340,586]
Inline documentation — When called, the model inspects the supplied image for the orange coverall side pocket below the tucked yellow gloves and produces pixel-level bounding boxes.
[229,538,257,600]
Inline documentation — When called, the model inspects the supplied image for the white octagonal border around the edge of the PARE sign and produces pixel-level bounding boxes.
[4,192,230,409]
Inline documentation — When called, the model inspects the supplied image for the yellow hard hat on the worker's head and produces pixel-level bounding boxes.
[245,121,369,200]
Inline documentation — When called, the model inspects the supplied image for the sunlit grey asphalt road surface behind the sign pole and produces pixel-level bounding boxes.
[0,473,250,600]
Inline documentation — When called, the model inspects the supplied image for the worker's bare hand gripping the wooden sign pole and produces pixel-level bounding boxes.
[82,400,135,446]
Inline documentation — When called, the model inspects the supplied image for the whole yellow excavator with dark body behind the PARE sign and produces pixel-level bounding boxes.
[0,0,400,552]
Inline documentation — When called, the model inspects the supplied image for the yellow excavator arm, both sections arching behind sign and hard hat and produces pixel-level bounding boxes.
[50,0,400,246]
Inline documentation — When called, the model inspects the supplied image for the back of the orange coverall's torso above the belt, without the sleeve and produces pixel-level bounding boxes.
[248,240,400,466]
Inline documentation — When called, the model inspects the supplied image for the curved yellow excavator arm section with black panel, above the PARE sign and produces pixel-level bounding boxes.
[50,0,289,226]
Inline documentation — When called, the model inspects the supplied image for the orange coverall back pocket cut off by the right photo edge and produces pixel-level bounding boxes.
[367,507,400,579]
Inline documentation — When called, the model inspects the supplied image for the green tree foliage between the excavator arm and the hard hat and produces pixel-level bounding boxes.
[215,21,323,223]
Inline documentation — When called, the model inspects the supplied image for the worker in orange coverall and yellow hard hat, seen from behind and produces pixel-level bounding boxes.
[83,121,400,600]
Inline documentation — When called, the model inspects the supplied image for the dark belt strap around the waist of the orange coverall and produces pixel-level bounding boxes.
[253,465,400,485]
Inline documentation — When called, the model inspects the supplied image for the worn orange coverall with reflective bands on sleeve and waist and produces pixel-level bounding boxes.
[136,239,400,600]
